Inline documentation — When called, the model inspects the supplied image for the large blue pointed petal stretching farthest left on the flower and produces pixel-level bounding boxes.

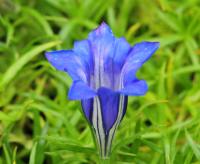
[45,50,87,82]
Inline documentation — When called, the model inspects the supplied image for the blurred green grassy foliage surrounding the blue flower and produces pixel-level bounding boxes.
[0,0,200,164]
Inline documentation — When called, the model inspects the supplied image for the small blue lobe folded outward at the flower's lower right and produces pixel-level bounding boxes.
[119,80,148,96]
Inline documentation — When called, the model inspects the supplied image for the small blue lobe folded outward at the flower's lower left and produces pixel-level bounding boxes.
[68,81,97,100]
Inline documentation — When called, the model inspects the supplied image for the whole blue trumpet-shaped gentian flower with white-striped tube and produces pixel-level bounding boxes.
[46,22,159,158]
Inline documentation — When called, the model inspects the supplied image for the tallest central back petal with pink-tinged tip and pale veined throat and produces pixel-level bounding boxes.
[88,23,115,89]
